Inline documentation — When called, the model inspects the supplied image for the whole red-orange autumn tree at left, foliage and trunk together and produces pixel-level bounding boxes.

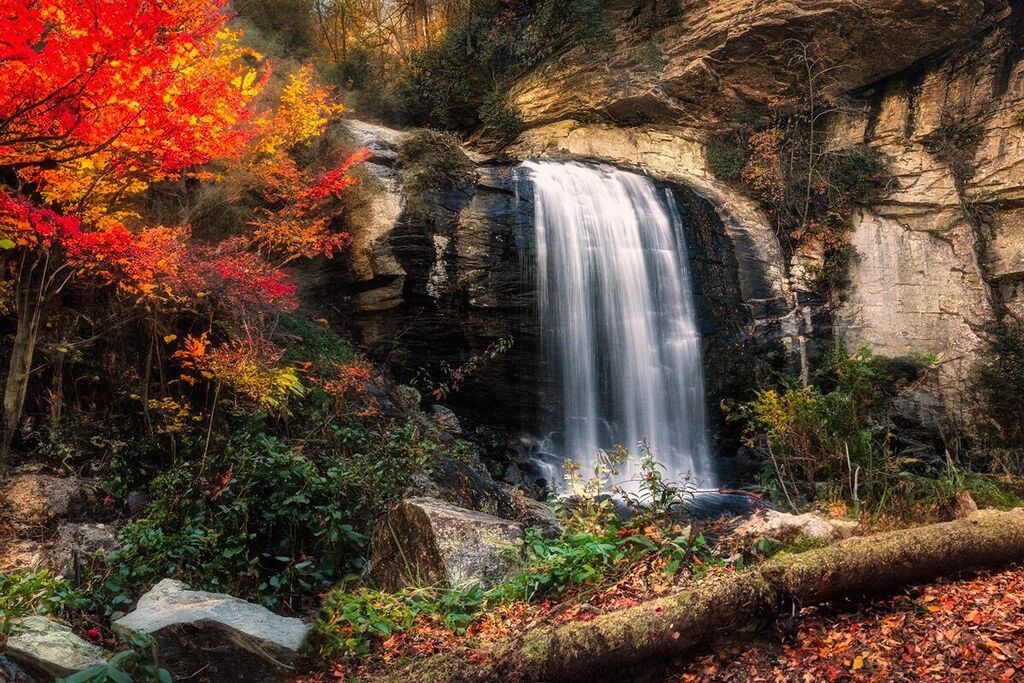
[0,0,261,470]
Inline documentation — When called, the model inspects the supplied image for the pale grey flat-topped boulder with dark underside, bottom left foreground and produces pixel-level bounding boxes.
[114,579,309,683]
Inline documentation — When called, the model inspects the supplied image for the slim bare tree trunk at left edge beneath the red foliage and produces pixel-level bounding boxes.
[0,273,43,478]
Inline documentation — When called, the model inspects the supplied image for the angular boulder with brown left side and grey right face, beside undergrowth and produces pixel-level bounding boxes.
[371,498,523,591]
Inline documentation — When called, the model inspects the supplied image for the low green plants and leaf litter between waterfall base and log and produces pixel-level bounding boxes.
[314,444,714,658]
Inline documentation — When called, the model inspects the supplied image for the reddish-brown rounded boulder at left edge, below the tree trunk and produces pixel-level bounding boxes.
[3,474,96,526]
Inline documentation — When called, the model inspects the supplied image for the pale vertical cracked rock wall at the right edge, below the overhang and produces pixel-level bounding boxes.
[830,7,1024,394]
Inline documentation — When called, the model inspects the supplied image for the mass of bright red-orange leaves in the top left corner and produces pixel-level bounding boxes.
[0,0,258,215]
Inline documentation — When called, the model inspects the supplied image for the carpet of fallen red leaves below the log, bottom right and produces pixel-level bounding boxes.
[666,567,1024,683]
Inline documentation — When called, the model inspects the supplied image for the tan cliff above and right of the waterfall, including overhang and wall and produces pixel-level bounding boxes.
[510,0,1024,417]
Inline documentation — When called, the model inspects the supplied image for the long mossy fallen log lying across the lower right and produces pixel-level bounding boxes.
[385,509,1024,683]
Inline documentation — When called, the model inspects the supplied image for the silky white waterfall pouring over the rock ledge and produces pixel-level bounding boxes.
[523,162,714,486]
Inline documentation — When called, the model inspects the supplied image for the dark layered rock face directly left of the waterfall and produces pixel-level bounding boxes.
[335,121,542,429]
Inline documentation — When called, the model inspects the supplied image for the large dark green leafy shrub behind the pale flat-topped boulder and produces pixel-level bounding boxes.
[96,432,364,609]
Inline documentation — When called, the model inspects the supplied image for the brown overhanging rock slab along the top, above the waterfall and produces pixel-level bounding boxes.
[510,0,1011,127]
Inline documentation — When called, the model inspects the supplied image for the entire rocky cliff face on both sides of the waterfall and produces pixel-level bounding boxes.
[343,0,1024,458]
